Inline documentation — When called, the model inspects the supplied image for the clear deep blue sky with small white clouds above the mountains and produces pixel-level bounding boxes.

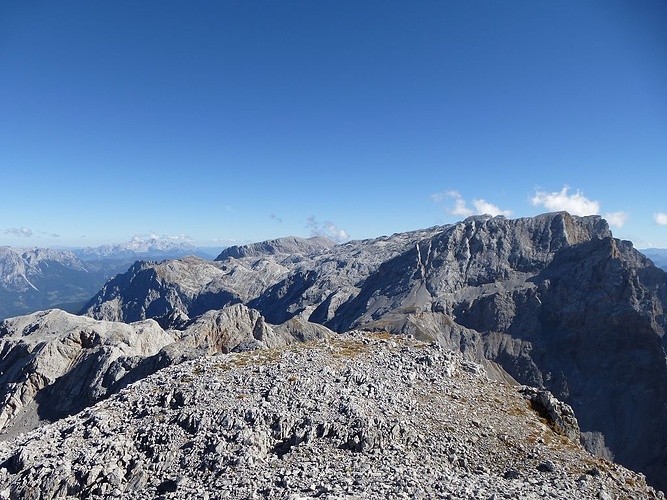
[0,0,667,248]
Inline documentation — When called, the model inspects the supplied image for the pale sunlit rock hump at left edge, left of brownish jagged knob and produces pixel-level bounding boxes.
[0,309,174,434]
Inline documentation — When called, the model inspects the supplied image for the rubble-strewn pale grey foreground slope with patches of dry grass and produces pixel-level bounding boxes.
[0,332,662,499]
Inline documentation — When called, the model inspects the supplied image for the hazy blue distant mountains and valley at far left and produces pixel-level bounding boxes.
[0,238,215,320]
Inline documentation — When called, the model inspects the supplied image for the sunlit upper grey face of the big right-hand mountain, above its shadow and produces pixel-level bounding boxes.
[331,213,611,330]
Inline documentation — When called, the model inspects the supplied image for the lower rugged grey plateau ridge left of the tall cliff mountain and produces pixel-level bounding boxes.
[81,228,448,327]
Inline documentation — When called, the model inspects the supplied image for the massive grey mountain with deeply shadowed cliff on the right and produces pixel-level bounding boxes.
[329,210,667,488]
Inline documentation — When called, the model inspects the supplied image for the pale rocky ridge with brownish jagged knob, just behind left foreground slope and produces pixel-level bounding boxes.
[0,304,331,438]
